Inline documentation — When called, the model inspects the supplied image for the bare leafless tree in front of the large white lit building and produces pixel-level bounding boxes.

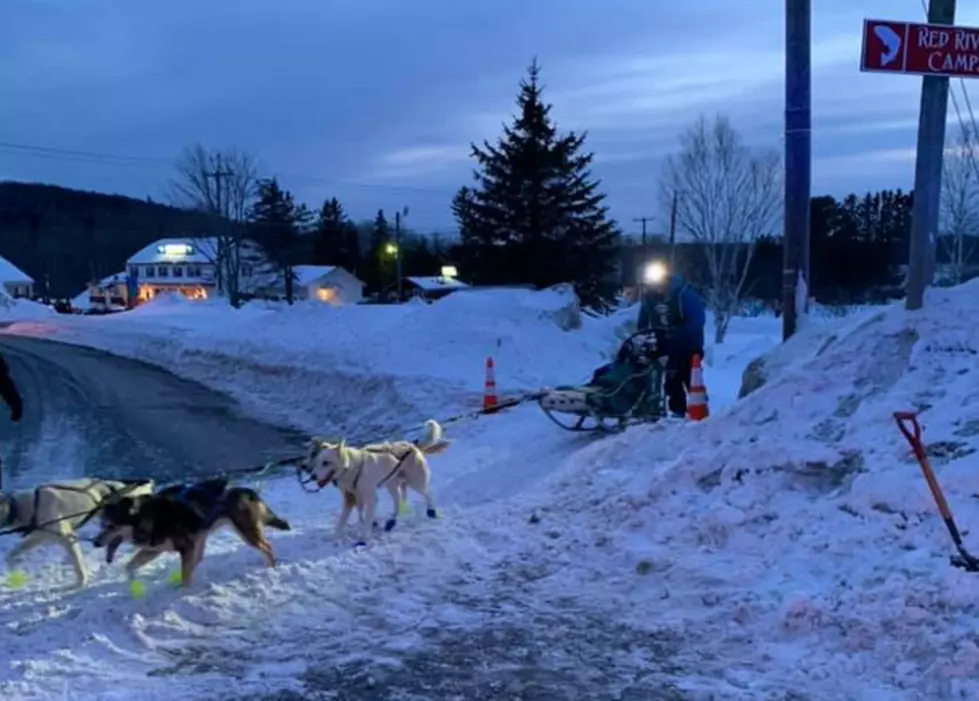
[171,144,259,306]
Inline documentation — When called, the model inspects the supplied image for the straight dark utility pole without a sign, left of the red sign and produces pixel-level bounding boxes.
[782,0,812,341]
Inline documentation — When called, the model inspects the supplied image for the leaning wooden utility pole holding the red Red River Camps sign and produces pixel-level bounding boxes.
[904,0,955,311]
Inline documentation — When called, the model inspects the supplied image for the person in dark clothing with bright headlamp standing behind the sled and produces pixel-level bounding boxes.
[638,263,707,417]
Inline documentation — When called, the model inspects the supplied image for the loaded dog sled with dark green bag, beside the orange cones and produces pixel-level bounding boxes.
[537,331,667,433]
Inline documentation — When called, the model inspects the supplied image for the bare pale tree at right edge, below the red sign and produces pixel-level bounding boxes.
[940,124,979,284]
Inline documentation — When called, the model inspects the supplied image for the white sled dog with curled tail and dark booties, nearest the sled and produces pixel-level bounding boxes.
[305,420,451,544]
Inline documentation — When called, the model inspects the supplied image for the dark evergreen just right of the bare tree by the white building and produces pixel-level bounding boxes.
[248,178,310,304]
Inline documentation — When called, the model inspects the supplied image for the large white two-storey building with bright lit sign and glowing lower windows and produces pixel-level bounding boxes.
[126,237,269,301]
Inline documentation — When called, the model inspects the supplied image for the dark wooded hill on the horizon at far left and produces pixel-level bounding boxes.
[0,181,209,297]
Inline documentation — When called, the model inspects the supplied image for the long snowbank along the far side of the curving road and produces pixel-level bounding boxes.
[8,288,621,435]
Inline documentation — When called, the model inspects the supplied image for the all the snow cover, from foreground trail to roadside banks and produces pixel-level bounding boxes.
[0,283,979,701]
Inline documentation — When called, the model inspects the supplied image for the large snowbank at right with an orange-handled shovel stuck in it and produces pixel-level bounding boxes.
[506,282,979,701]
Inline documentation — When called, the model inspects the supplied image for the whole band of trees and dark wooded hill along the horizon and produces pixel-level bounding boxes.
[0,61,979,330]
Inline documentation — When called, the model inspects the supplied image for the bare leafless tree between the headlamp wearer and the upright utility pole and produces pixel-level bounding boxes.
[660,115,782,343]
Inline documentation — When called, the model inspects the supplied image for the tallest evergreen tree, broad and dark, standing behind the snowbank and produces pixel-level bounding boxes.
[452,60,619,305]
